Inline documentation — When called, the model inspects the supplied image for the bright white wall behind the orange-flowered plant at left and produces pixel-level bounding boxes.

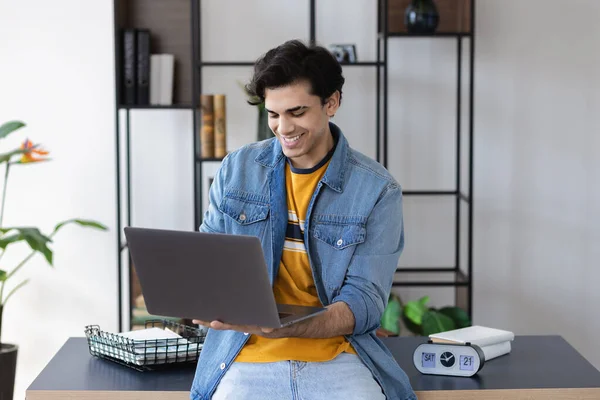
[0,0,117,400]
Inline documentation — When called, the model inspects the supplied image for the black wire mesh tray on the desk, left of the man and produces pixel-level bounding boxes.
[85,320,206,371]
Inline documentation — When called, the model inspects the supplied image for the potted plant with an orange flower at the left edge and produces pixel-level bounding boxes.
[0,121,106,400]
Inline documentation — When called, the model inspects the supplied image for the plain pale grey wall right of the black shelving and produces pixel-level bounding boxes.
[474,0,600,367]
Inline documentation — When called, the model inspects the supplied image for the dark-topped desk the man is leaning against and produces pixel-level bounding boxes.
[26,336,600,400]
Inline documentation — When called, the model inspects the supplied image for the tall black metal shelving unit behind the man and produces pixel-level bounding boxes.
[114,0,475,330]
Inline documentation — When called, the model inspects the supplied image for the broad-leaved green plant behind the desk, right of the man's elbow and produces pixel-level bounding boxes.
[381,293,471,336]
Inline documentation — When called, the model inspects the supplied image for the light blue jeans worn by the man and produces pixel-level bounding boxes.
[212,353,385,400]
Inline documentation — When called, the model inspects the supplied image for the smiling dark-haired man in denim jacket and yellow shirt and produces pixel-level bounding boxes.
[191,41,416,400]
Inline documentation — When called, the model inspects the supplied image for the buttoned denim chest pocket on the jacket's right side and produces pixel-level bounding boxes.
[313,216,367,250]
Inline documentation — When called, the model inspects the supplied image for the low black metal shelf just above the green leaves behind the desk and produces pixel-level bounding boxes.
[392,268,471,287]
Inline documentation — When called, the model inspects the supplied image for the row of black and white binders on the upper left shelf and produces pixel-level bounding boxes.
[121,29,175,106]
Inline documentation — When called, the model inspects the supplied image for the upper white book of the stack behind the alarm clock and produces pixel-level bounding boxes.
[429,325,515,347]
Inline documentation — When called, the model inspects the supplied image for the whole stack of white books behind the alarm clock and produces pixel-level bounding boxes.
[429,325,515,361]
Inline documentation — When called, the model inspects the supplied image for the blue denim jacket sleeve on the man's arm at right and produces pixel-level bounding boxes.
[333,185,404,335]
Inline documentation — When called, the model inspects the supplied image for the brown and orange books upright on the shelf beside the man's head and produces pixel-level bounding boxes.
[200,94,227,159]
